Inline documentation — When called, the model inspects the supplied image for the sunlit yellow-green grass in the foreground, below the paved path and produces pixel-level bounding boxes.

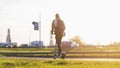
[0,58,120,68]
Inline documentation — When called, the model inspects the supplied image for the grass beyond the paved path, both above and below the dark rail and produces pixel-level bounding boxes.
[0,46,120,57]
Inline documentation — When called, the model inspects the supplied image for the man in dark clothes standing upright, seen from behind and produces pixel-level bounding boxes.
[51,14,65,56]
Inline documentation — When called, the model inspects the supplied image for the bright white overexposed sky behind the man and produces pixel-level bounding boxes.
[0,0,120,45]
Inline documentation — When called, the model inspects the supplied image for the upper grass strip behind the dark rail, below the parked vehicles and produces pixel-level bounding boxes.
[0,46,120,52]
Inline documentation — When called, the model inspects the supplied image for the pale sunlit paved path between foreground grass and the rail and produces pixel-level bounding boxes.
[0,57,120,62]
